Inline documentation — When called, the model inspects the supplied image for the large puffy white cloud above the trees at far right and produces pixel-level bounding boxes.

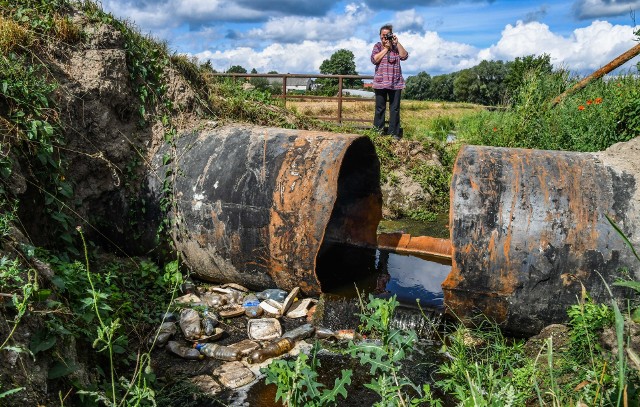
[478,21,635,74]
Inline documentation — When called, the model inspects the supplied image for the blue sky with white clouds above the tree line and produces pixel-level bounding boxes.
[102,0,640,77]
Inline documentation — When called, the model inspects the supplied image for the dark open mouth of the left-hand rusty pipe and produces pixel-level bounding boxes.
[316,137,382,291]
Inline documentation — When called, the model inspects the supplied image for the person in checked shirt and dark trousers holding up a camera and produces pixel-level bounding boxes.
[371,24,409,140]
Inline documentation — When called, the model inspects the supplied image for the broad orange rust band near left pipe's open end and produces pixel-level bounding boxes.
[268,134,355,294]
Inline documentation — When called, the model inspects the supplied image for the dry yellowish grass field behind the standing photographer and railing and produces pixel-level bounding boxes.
[287,99,482,138]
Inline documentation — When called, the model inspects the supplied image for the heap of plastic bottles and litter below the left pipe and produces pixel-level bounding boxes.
[159,254,444,402]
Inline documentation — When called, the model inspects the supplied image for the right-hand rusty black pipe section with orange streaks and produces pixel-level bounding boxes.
[442,143,640,335]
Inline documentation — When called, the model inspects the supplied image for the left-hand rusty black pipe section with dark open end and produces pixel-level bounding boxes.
[151,125,382,295]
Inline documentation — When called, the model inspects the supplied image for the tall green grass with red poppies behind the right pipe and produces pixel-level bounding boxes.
[457,71,640,151]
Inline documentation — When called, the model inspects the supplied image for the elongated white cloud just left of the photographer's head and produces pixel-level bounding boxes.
[246,3,373,43]
